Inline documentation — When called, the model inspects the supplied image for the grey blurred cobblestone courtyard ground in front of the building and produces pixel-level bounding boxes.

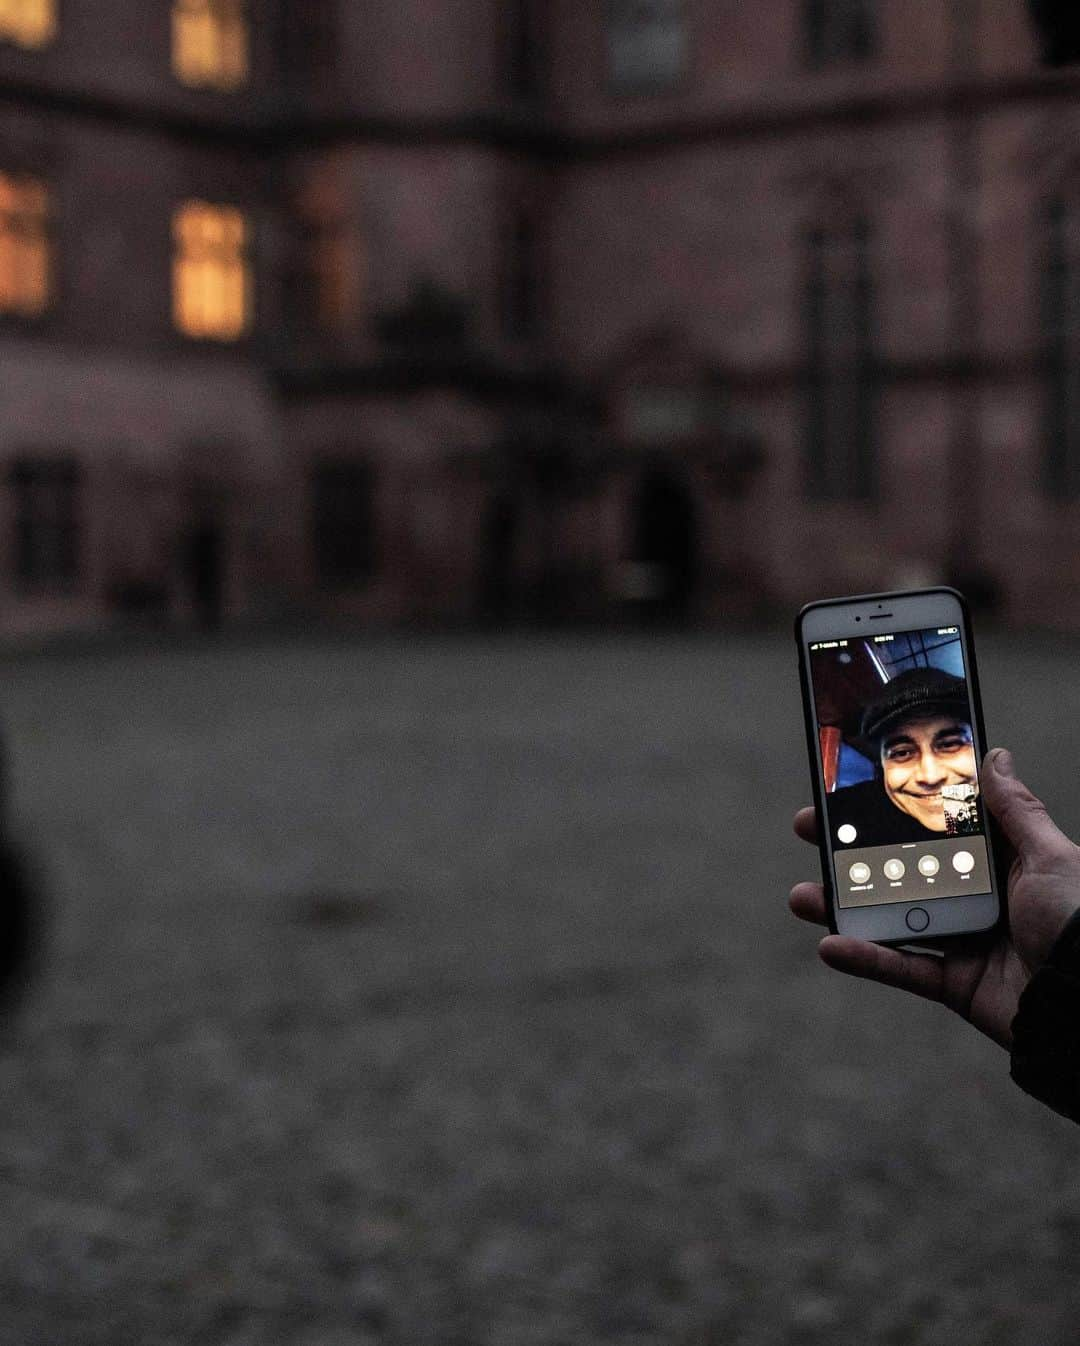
[0,633,1080,1346]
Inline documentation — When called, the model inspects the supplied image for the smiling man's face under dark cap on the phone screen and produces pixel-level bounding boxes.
[881,716,976,832]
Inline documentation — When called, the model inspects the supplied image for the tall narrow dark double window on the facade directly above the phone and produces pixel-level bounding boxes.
[805,221,877,499]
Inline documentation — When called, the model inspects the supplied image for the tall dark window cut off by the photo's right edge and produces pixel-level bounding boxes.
[1042,199,1080,498]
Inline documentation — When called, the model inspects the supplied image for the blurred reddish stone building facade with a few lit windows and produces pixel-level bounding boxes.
[0,0,1080,633]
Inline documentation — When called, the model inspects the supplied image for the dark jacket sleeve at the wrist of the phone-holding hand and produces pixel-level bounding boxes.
[1011,911,1080,1123]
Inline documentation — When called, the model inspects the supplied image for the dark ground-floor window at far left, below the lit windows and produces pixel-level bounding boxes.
[9,458,79,592]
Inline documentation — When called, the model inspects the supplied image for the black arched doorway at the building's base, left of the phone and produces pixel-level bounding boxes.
[630,460,700,622]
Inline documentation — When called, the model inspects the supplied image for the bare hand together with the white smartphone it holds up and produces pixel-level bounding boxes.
[790,588,1080,1046]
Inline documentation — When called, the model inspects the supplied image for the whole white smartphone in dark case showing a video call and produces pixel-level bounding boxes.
[796,588,1005,944]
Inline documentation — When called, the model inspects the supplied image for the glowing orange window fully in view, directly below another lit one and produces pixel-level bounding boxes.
[172,201,252,341]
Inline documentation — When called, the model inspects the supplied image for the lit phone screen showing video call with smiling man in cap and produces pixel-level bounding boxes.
[809,626,992,907]
